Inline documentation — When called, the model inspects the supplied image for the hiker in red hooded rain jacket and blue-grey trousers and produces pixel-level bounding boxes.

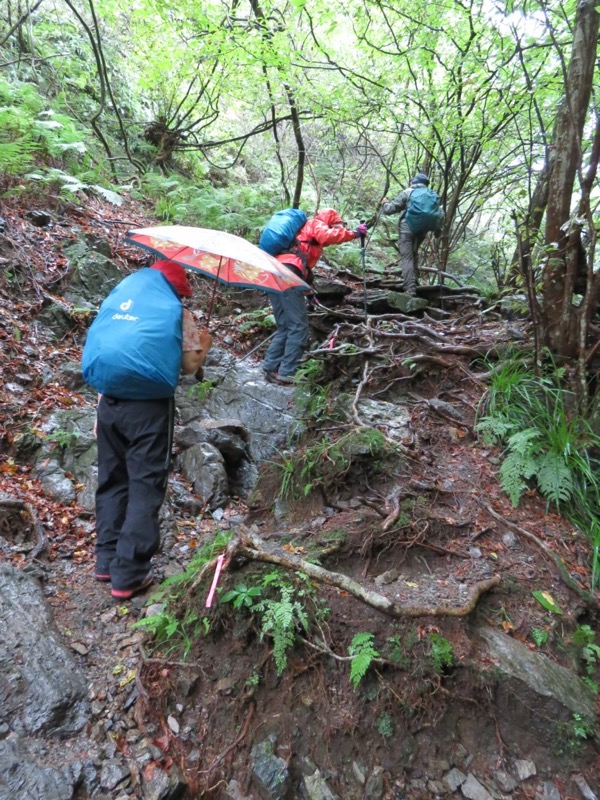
[263,208,367,384]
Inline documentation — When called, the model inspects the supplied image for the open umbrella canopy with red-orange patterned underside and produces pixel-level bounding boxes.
[126,225,309,292]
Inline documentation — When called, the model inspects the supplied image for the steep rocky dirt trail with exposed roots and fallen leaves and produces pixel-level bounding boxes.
[0,199,600,800]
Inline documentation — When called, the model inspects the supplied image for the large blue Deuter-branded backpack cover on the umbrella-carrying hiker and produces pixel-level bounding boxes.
[81,269,183,400]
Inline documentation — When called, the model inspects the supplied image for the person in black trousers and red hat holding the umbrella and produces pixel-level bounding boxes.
[89,260,212,600]
